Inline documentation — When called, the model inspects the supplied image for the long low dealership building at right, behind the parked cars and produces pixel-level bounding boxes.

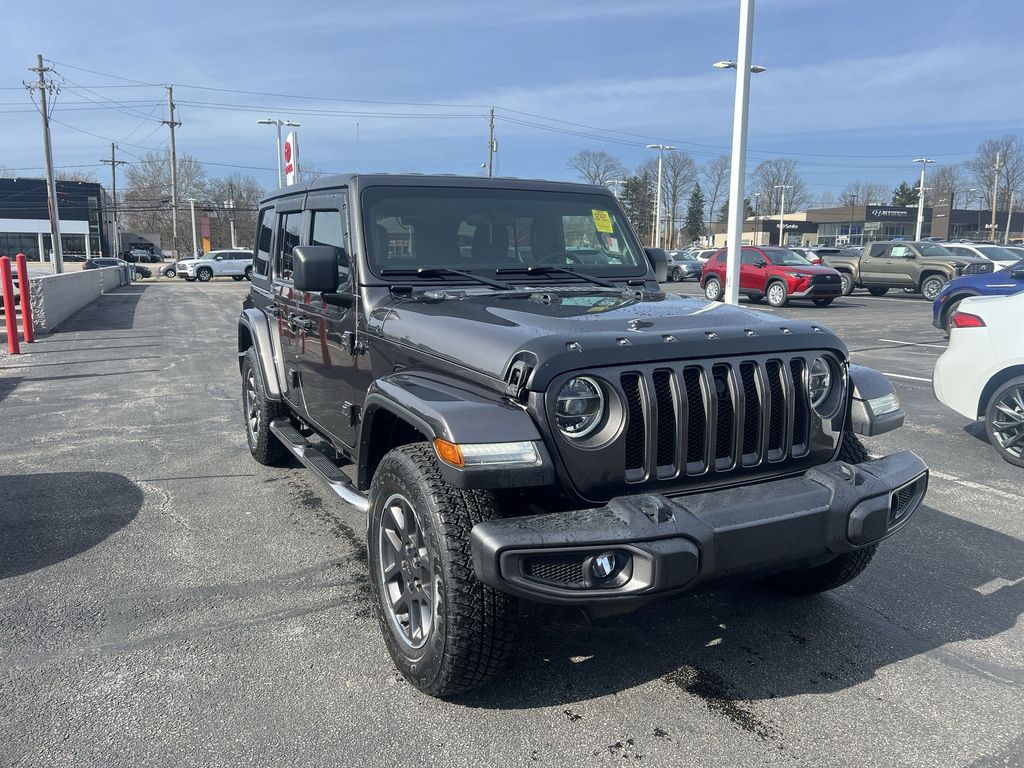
[715,200,1024,246]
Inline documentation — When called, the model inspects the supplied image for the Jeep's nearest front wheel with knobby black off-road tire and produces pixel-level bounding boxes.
[367,442,518,696]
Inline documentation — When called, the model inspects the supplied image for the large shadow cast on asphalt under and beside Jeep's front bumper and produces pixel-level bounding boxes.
[457,507,1024,708]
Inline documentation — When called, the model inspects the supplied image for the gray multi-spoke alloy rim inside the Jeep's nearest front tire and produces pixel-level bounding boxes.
[379,494,435,648]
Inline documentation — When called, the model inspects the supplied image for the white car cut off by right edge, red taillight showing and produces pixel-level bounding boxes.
[932,288,1024,467]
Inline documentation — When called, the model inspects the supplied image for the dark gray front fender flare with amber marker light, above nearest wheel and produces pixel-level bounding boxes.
[358,371,554,488]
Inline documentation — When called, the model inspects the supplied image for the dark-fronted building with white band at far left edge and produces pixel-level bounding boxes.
[0,178,111,261]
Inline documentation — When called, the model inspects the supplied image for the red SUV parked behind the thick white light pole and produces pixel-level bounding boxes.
[700,246,843,306]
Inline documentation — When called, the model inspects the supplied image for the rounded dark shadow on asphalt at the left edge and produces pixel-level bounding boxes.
[0,472,143,579]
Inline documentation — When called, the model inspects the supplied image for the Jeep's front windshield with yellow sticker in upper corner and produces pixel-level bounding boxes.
[362,186,647,276]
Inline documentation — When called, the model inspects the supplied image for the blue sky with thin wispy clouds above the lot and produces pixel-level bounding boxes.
[0,0,1024,202]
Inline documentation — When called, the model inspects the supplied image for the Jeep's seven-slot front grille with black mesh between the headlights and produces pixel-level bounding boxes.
[620,356,811,482]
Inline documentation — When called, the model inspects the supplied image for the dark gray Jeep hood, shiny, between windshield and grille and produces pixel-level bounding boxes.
[370,289,846,390]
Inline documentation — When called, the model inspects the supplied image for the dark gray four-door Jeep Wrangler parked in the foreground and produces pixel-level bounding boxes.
[239,175,928,696]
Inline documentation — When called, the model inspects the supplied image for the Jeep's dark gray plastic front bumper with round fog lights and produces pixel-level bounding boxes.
[471,451,928,612]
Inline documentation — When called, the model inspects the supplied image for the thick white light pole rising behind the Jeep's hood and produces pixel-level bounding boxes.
[714,17,765,304]
